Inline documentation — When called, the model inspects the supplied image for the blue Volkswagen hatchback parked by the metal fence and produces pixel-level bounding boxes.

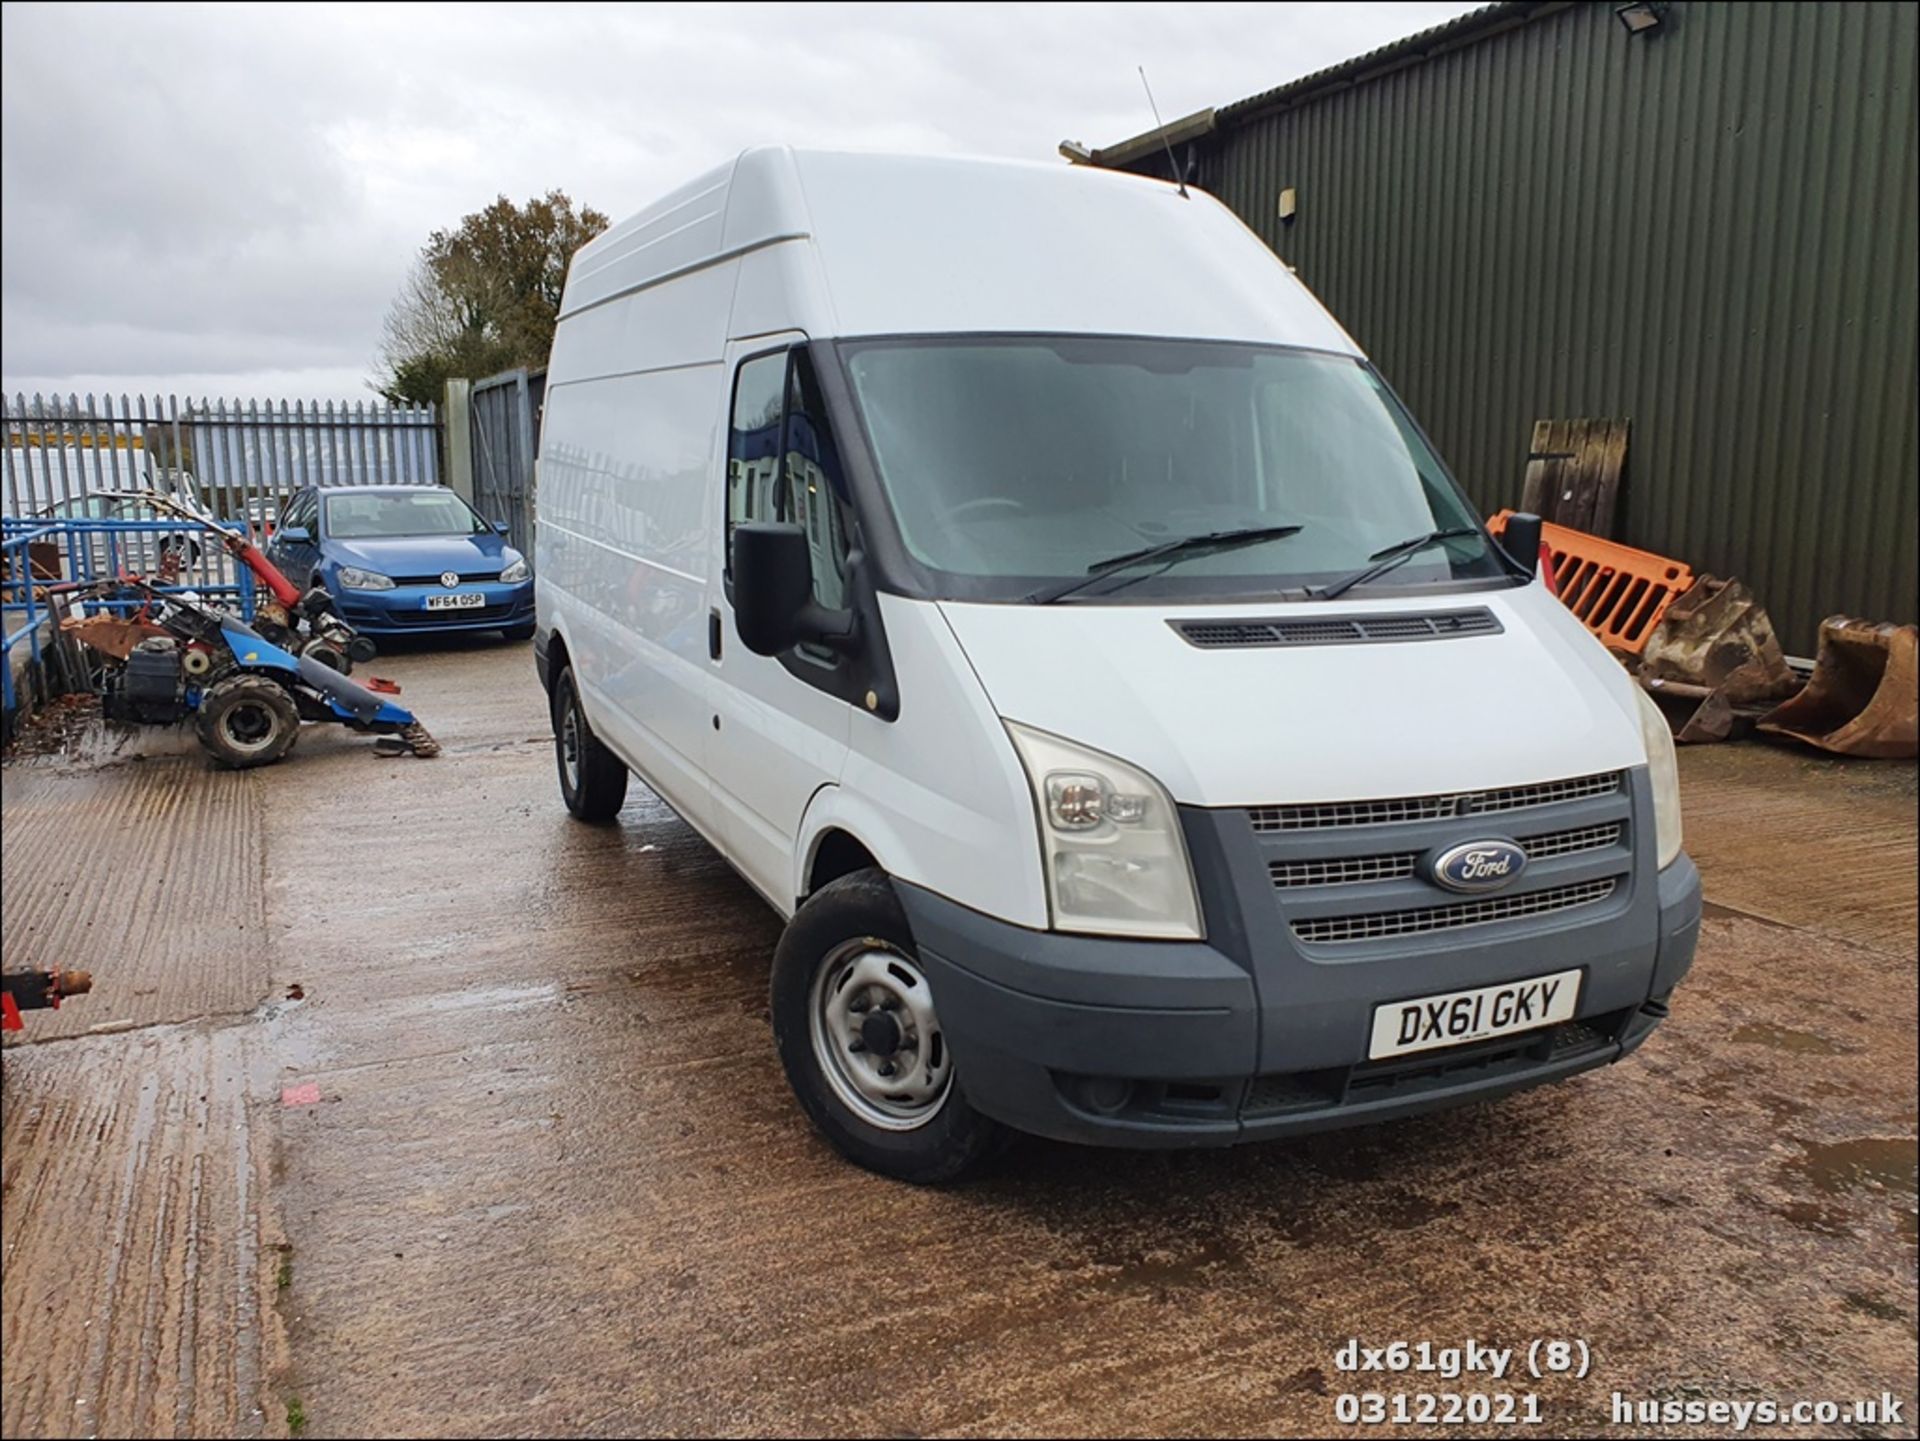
[267,485,534,641]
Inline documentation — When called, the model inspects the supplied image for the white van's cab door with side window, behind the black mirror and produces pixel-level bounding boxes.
[707,332,852,911]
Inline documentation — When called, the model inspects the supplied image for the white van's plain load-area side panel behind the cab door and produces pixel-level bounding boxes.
[536,263,735,829]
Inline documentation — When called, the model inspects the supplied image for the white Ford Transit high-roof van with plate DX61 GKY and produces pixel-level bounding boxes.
[536,150,1699,1180]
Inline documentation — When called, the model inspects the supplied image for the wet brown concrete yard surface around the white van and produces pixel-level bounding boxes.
[4,645,1916,1435]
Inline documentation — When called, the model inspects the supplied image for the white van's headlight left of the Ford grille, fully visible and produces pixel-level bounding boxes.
[1006,721,1206,940]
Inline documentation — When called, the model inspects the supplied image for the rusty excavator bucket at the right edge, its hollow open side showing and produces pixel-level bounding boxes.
[1759,616,1920,760]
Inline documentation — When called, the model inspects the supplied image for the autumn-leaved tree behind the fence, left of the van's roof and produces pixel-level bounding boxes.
[378,190,607,405]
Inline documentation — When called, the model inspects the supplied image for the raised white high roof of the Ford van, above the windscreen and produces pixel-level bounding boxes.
[561,146,1359,355]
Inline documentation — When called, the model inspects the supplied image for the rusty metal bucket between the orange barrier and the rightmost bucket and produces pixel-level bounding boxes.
[1640,576,1801,744]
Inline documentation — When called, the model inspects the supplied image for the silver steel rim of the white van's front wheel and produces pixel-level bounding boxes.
[806,936,952,1130]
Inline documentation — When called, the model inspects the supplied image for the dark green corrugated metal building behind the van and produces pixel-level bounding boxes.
[1092,0,1920,654]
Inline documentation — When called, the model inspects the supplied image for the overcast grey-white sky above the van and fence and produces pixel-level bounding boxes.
[0,2,1473,399]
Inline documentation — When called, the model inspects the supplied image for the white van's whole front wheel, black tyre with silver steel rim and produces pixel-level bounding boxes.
[772,869,1006,1186]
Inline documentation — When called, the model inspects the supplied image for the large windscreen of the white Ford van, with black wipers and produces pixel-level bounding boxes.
[841,336,1505,601]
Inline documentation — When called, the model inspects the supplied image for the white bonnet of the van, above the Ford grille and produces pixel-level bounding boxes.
[941,583,1645,806]
